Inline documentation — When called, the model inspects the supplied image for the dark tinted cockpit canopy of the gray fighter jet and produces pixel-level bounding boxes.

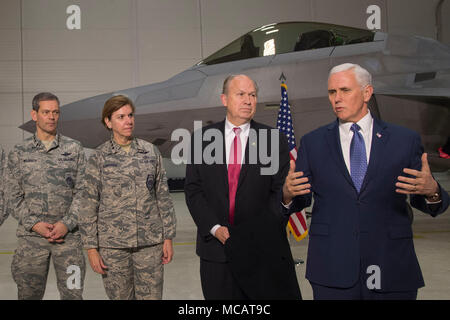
[199,22,375,65]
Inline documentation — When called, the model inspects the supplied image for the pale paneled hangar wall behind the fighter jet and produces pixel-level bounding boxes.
[0,0,450,150]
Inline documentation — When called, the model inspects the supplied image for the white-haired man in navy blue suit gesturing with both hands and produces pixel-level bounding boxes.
[283,63,449,299]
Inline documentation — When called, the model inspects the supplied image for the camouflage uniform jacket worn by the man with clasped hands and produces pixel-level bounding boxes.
[5,134,86,237]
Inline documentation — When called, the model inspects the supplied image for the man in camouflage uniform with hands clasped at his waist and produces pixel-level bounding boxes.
[6,93,86,300]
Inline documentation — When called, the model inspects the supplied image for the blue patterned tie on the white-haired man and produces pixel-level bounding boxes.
[350,123,367,193]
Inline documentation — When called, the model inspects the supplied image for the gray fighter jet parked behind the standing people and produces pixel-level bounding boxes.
[21,22,450,170]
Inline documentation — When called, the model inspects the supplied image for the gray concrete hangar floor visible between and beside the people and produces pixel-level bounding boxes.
[0,171,450,300]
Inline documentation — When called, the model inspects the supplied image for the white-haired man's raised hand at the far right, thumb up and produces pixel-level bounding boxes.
[395,153,439,196]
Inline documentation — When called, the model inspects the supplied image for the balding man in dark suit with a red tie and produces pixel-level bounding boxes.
[185,75,301,299]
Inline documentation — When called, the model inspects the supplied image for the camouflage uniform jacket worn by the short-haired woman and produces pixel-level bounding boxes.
[77,139,176,249]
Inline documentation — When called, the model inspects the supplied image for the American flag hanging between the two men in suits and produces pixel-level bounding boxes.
[277,82,308,241]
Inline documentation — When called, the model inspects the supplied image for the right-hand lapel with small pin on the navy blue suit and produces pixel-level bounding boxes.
[360,118,389,193]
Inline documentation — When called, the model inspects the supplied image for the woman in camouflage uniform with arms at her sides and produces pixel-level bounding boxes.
[79,96,176,300]
